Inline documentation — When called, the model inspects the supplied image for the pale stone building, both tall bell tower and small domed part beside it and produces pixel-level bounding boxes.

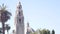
[13,2,35,34]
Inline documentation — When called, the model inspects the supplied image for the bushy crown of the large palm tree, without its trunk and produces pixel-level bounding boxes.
[0,4,12,22]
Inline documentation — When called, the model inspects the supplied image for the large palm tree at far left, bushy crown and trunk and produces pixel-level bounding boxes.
[0,4,11,34]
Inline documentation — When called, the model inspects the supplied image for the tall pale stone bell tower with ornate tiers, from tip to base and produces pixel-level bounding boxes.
[15,2,24,34]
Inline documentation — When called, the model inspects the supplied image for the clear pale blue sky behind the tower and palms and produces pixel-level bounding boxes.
[0,0,60,34]
